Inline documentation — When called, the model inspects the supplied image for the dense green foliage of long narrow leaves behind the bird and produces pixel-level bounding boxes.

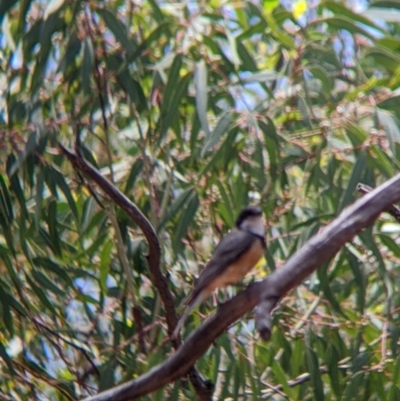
[0,0,400,401]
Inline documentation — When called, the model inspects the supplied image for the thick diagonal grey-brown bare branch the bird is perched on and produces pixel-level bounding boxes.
[79,175,400,401]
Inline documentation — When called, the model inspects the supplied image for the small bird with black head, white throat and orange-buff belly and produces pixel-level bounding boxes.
[172,206,266,338]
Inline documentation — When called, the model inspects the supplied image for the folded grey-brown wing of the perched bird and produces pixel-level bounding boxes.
[188,229,255,305]
